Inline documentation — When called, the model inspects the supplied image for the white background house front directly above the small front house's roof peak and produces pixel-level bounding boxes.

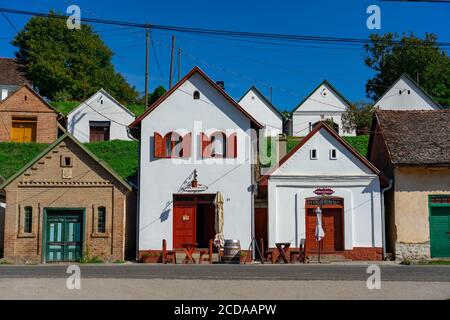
[289,80,356,137]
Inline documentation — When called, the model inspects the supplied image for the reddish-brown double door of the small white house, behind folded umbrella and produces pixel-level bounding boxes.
[306,208,344,252]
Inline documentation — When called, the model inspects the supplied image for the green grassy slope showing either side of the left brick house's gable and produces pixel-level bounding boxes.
[0,141,138,179]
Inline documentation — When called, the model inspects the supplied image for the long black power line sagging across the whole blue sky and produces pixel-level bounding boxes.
[0,8,450,47]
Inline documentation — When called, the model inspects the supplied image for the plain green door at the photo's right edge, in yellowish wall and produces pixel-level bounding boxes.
[430,206,450,258]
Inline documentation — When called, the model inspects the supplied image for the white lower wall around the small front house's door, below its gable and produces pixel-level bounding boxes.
[268,177,382,250]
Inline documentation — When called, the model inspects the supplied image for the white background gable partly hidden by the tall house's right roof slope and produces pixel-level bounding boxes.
[239,86,285,136]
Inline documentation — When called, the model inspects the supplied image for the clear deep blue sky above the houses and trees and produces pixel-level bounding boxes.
[0,0,450,110]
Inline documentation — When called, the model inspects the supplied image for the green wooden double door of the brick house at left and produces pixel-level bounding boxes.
[46,212,83,262]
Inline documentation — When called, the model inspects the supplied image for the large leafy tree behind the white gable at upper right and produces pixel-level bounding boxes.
[365,33,450,106]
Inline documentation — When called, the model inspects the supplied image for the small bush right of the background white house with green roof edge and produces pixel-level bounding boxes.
[342,101,374,133]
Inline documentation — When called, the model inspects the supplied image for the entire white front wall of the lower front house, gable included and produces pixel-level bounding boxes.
[268,128,382,250]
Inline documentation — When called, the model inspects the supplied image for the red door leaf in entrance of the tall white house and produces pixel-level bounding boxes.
[173,206,196,249]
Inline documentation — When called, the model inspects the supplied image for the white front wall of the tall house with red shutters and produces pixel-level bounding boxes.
[139,73,252,250]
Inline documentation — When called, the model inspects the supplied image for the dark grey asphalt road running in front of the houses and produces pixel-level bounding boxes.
[0,264,450,283]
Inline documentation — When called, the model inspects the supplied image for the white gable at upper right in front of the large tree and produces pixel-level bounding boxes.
[375,73,441,111]
